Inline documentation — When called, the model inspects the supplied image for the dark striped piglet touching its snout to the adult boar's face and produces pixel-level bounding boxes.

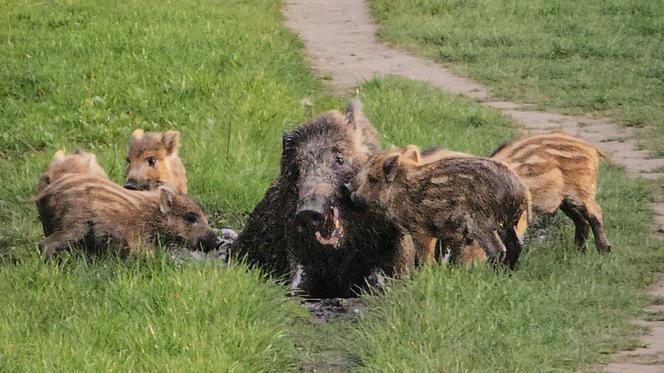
[350,152,530,268]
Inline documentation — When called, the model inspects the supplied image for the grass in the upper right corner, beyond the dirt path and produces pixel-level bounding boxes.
[370,0,664,154]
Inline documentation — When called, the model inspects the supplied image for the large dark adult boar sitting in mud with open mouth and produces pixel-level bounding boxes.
[231,100,414,297]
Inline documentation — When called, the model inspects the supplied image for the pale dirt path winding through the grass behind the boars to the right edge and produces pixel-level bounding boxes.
[284,0,664,372]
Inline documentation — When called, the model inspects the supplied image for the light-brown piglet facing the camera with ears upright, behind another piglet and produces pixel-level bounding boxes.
[124,129,187,193]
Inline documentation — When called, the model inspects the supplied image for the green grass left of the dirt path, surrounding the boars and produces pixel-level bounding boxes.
[0,0,664,372]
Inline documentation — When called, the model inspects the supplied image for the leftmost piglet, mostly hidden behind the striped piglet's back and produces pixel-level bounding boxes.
[37,149,108,192]
